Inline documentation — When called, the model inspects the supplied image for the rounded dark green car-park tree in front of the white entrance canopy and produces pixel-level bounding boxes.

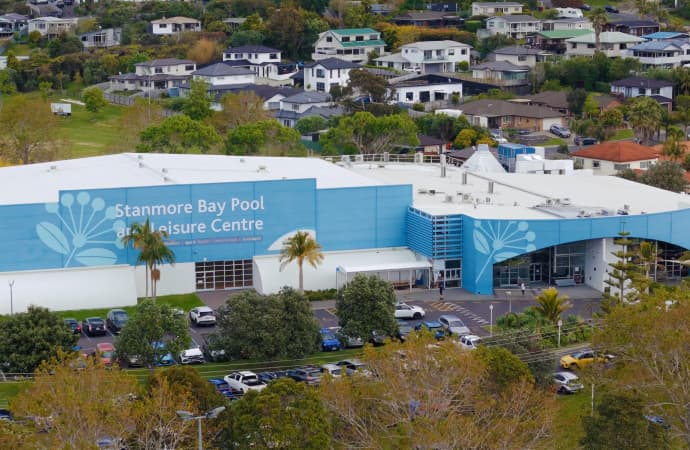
[335,274,398,338]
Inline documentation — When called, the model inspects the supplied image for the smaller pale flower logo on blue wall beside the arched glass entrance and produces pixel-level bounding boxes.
[472,220,537,282]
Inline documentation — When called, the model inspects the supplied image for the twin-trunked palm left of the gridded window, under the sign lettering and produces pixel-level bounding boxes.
[122,218,175,302]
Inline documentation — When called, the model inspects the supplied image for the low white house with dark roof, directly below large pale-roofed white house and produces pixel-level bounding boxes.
[389,74,462,107]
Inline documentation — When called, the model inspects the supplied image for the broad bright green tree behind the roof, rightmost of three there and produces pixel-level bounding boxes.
[321,112,419,153]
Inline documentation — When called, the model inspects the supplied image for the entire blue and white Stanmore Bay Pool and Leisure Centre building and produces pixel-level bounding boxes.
[0,150,690,313]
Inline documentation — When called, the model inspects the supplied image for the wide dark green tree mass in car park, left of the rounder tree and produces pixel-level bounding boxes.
[217,288,320,359]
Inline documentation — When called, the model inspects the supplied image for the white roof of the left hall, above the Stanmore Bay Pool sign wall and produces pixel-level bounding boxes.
[0,153,382,205]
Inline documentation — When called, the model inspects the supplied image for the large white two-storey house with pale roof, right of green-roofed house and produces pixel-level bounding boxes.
[375,40,472,73]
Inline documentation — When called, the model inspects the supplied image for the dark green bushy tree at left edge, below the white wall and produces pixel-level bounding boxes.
[0,305,79,374]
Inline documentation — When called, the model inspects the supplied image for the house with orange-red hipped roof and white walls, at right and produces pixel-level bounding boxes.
[572,141,659,175]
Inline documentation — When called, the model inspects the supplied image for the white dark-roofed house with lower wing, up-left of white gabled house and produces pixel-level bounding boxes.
[223,45,298,85]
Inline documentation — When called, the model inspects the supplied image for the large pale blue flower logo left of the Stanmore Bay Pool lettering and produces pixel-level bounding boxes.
[36,192,125,267]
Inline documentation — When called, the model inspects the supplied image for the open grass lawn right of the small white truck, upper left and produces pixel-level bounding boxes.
[57,99,126,158]
